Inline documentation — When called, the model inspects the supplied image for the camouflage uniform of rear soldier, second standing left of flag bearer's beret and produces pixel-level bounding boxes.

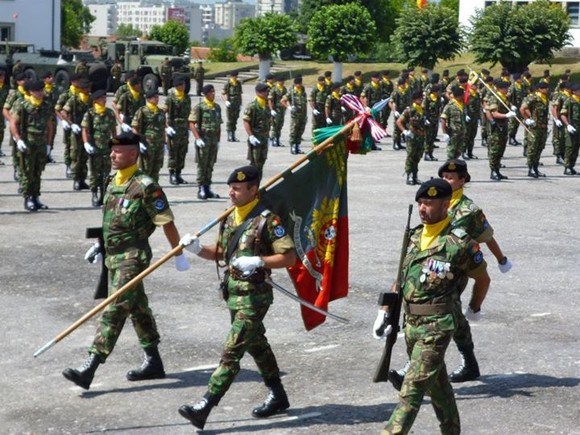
[164,89,191,176]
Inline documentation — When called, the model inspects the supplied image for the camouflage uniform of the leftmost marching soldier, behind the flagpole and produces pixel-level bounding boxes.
[89,170,173,362]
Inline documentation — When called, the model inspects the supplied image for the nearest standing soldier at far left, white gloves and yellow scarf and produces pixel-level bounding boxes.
[10,80,54,212]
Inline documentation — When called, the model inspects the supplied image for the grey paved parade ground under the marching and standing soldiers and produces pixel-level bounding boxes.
[0,83,580,435]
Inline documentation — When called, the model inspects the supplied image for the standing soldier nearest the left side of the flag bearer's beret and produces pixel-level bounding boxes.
[189,85,223,199]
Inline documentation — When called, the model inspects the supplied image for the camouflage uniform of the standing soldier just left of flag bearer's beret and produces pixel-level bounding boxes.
[189,101,223,187]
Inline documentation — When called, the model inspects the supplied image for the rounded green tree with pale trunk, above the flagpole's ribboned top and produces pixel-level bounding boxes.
[306,3,377,81]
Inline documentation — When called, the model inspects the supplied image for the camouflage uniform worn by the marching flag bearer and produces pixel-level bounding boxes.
[208,205,294,397]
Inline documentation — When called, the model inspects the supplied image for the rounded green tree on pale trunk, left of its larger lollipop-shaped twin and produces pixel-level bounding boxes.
[234,13,297,80]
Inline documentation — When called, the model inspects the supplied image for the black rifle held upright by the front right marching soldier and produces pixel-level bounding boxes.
[373,204,413,382]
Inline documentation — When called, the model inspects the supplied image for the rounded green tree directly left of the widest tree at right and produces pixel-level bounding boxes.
[392,5,464,69]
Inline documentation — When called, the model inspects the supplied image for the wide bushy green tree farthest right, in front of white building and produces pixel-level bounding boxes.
[469,0,571,72]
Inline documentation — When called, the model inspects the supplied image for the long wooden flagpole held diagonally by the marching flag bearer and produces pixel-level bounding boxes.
[34,117,360,358]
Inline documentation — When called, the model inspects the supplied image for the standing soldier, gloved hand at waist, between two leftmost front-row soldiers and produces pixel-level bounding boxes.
[60,79,93,190]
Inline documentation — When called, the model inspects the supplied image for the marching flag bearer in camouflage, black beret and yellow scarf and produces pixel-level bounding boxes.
[179,166,296,429]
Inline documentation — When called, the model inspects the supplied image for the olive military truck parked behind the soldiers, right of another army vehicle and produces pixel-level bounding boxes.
[101,39,191,92]
